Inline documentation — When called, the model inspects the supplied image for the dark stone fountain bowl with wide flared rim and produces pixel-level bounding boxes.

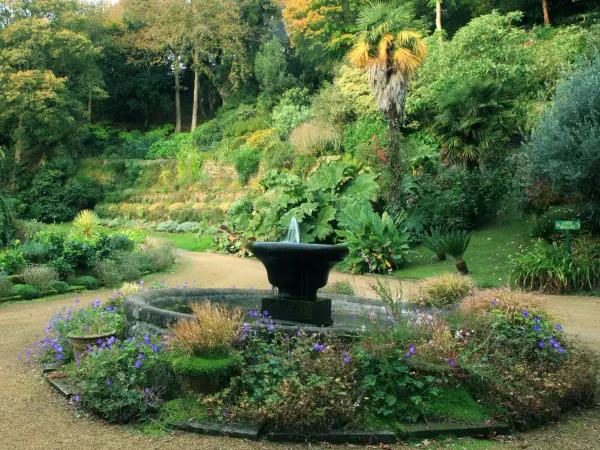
[248,242,348,300]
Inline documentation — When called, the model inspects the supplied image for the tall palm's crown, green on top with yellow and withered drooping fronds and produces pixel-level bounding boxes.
[349,2,427,130]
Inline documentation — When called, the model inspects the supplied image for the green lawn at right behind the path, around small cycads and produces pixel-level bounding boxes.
[394,219,531,287]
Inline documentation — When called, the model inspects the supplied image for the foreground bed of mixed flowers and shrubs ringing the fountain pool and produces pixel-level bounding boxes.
[25,284,599,442]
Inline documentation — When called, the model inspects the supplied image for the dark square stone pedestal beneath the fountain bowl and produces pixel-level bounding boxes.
[262,296,333,327]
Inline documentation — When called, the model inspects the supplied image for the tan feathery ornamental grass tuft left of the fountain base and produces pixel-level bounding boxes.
[169,301,243,357]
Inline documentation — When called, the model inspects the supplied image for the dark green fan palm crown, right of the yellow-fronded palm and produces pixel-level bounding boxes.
[433,78,508,166]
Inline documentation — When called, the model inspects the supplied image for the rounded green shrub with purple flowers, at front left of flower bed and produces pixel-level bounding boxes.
[76,337,178,423]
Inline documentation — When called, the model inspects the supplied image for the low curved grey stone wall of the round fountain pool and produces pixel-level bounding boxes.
[124,288,422,336]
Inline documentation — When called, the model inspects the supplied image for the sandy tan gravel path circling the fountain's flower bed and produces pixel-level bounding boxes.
[0,251,600,450]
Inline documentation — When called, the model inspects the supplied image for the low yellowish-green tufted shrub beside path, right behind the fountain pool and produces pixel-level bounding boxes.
[419,273,473,308]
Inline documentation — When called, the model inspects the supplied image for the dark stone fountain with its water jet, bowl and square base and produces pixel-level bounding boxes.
[248,217,348,326]
